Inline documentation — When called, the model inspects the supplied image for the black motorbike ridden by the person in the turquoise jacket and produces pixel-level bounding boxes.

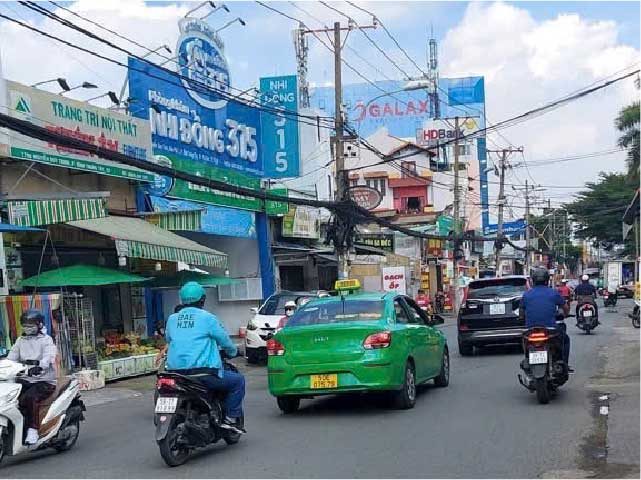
[154,357,244,467]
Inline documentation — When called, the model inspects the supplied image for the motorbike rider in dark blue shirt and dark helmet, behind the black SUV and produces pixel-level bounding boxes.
[519,267,573,372]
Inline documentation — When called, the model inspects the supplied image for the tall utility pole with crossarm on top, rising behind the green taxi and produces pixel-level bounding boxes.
[298,22,376,279]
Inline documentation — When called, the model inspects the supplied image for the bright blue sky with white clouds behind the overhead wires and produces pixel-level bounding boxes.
[0,0,641,221]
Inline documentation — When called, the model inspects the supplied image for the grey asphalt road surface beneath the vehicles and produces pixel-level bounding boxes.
[0,302,638,478]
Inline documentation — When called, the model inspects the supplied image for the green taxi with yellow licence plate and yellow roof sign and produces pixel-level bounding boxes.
[267,280,450,413]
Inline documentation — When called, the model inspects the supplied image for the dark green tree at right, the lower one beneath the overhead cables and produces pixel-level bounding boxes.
[565,172,638,249]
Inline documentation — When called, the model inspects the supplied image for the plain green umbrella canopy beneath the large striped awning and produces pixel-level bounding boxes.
[20,265,148,288]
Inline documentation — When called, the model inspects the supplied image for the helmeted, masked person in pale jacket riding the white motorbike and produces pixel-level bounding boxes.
[7,309,58,445]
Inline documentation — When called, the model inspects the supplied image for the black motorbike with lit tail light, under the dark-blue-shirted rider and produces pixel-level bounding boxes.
[518,314,569,404]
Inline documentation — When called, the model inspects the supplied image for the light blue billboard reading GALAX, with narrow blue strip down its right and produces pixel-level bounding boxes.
[310,77,490,231]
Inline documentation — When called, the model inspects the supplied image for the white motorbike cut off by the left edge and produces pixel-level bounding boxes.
[0,358,86,461]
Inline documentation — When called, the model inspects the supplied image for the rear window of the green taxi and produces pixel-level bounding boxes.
[285,299,384,328]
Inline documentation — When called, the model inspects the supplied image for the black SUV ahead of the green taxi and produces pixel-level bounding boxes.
[457,276,529,355]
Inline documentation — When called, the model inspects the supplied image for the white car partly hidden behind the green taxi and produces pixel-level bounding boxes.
[245,290,329,363]
